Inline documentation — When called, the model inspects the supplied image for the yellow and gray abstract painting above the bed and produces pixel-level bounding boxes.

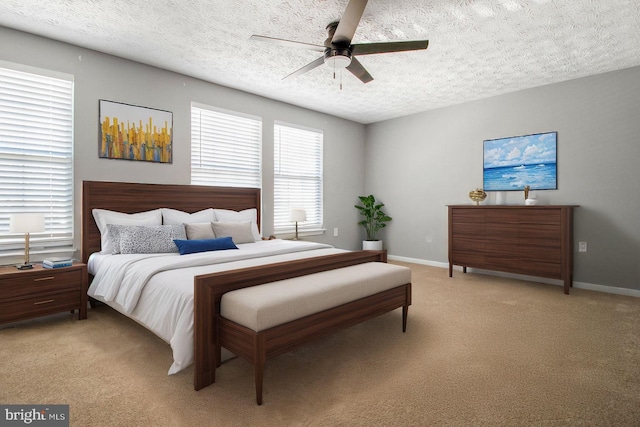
[98,99,173,163]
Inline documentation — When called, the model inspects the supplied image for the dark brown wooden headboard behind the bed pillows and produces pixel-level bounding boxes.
[81,181,260,262]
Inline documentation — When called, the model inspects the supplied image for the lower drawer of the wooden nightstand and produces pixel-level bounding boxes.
[0,288,80,323]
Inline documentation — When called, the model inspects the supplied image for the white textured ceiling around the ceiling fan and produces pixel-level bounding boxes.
[0,0,640,123]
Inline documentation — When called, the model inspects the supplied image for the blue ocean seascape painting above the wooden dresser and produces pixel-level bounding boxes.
[483,132,558,191]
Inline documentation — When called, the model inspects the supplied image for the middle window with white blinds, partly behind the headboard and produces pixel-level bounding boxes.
[191,103,262,188]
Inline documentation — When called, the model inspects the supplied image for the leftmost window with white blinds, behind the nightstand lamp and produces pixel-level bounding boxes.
[0,62,73,256]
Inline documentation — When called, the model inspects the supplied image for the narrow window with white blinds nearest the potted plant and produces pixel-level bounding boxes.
[273,123,323,233]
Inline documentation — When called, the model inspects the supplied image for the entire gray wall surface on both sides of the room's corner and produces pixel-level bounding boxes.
[0,27,640,290]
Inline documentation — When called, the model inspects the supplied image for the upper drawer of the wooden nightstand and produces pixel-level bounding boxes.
[0,269,82,303]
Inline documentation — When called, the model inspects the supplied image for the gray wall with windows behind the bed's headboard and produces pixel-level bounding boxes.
[0,27,365,249]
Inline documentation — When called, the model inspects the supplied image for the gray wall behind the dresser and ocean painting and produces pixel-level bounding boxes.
[365,68,640,290]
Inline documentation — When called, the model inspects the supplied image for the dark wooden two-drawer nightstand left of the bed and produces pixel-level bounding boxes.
[0,263,88,324]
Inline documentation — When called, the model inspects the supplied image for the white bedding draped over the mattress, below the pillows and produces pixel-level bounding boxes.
[88,239,346,374]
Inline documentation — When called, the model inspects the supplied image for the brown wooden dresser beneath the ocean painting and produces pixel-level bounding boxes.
[449,205,576,294]
